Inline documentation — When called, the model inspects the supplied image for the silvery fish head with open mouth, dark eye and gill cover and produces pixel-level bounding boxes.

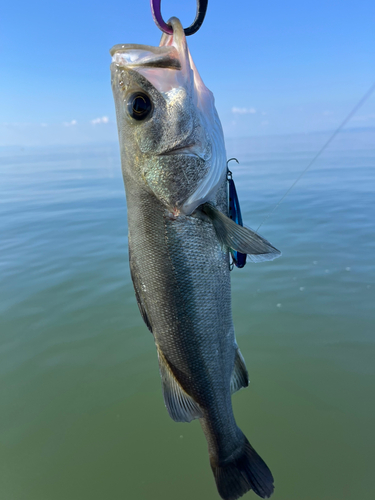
[111,18,226,214]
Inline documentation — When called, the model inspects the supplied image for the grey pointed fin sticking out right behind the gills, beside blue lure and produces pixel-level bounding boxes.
[202,203,281,262]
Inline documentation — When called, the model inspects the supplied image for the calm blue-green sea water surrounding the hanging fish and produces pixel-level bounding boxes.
[0,131,375,500]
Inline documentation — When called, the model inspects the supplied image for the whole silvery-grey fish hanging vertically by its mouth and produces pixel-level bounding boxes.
[110,18,280,500]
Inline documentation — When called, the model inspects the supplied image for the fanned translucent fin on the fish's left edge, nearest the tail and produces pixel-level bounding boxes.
[157,347,203,422]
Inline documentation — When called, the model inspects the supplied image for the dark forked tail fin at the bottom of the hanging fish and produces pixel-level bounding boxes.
[211,434,274,500]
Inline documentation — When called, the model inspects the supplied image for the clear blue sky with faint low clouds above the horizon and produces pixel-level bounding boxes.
[0,0,375,146]
